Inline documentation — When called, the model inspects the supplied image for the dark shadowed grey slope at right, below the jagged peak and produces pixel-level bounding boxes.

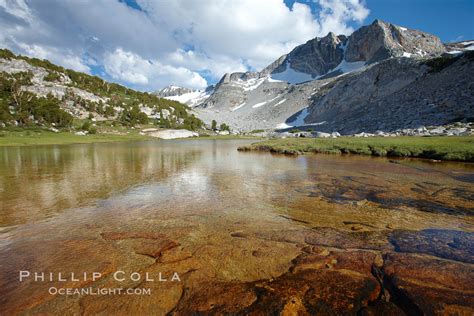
[305,52,474,134]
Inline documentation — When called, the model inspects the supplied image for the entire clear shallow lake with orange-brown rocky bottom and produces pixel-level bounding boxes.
[0,140,474,315]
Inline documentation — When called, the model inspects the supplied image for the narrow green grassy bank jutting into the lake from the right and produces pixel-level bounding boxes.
[238,136,474,162]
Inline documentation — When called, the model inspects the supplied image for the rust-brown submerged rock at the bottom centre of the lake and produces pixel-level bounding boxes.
[175,247,381,315]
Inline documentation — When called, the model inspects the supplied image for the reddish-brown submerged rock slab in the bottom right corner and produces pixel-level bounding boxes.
[383,253,474,315]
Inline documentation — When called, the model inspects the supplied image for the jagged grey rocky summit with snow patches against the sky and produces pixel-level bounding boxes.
[264,19,446,83]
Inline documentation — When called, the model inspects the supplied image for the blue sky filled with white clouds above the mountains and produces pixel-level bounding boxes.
[0,0,474,91]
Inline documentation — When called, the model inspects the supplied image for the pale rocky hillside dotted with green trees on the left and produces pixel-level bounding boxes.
[0,49,202,129]
